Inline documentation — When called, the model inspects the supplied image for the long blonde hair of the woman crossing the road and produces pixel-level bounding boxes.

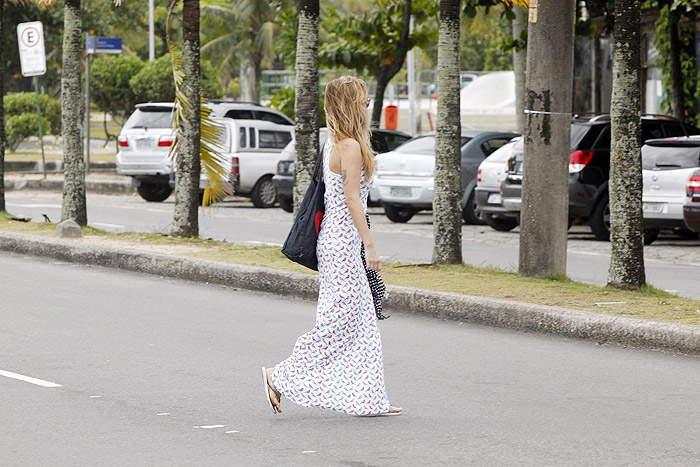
[323,76,374,178]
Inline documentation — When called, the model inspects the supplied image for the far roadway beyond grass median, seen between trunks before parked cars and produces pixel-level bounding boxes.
[7,191,700,299]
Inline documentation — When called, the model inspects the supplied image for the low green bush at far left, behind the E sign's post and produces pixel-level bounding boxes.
[3,92,61,151]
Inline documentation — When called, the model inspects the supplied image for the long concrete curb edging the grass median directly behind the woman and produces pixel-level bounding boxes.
[0,232,700,356]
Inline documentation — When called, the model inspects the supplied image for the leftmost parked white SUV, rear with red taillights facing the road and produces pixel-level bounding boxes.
[117,101,294,201]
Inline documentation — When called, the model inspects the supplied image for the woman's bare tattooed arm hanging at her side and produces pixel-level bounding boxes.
[335,138,381,271]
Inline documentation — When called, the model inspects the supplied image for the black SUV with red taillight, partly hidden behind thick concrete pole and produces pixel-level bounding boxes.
[502,115,700,241]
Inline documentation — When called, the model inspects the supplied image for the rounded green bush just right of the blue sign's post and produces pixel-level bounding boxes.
[90,55,144,120]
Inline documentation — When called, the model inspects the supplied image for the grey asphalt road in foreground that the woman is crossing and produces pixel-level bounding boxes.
[0,253,700,467]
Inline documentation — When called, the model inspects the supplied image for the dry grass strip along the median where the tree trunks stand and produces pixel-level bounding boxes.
[0,213,700,325]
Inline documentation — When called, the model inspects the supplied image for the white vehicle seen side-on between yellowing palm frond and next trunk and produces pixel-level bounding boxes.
[176,118,294,208]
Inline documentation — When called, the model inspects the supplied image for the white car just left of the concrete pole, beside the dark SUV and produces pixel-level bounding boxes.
[474,137,520,232]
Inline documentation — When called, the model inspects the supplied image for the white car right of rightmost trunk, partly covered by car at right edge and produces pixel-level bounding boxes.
[642,138,700,241]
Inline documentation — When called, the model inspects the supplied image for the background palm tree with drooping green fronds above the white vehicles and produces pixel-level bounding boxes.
[202,0,277,102]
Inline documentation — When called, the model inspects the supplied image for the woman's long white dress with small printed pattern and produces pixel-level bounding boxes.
[272,138,389,415]
